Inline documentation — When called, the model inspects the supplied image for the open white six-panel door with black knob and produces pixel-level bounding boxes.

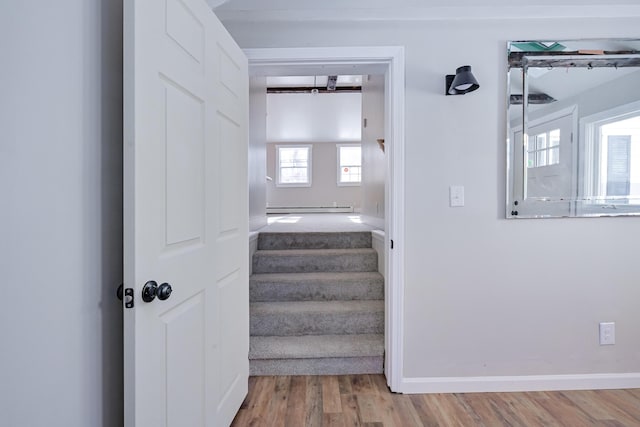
[124,0,249,427]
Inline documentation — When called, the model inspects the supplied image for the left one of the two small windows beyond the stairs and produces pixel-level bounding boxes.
[276,145,311,187]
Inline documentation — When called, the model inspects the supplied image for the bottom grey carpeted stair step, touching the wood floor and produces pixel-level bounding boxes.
[249,334,384,375]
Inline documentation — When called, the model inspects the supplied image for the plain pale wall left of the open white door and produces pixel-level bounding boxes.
[0,0,123,427]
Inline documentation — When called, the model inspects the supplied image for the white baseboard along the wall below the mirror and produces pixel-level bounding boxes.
[394,372,640,394]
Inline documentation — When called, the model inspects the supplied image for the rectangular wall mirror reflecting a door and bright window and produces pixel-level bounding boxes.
[507,40,640,218]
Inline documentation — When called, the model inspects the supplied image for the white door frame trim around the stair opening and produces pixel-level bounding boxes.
[244,46,405,392]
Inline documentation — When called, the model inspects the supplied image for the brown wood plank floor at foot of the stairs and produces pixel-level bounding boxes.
[232,375,640,427]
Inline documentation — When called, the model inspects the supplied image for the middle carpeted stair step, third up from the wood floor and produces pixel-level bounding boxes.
[249,271,384,302]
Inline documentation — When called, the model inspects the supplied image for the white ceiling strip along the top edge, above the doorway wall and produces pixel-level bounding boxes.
[215,0,640,21]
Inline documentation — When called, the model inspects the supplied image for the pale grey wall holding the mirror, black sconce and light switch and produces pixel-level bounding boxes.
[222,18,640,379]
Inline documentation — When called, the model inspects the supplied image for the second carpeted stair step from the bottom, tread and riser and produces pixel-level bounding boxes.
[250,300,384,336]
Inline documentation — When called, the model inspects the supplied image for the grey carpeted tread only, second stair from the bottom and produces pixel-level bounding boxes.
[249,300,384,316]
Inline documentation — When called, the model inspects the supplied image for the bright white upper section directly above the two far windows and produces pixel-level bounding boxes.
[267,92,362,143]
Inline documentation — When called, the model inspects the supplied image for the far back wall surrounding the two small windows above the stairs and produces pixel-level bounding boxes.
[267,142,361,210]
